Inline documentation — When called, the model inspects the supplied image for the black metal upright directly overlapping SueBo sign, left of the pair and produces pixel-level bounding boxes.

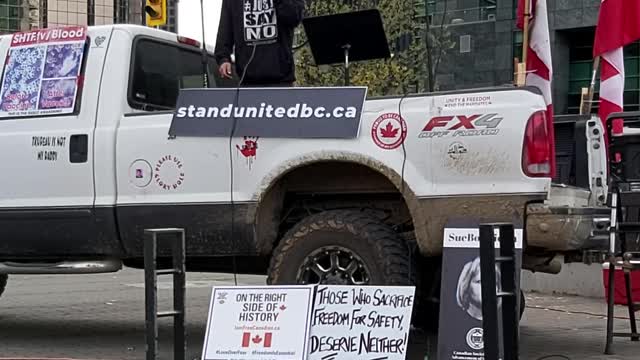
[479,225,499,360]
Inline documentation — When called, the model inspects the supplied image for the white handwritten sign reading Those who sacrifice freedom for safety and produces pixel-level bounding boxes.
[309,285,415,360]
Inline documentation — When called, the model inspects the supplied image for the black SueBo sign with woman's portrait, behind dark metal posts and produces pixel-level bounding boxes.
[438,222,522,360]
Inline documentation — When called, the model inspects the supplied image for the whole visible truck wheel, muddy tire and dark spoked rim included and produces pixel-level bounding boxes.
[267,210,413,285]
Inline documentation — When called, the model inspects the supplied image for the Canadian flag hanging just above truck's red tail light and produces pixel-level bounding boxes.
[516,0,556,176]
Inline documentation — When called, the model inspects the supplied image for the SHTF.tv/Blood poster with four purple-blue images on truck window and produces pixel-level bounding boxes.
[0,26,87,118]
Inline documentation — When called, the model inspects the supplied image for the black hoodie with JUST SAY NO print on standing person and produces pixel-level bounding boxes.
[215,0,305,85]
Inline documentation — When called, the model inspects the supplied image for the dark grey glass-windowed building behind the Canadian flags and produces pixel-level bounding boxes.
[424,0,640,114]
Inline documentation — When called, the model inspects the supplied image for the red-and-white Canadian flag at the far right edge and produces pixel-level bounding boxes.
[593,0,640,137]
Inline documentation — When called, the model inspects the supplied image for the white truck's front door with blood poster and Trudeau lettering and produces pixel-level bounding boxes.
[0,27,106,259]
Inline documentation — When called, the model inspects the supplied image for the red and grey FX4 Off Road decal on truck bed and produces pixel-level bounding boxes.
[418,114,502,139]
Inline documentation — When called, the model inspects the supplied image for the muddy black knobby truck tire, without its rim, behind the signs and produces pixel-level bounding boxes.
[267,210,428,325]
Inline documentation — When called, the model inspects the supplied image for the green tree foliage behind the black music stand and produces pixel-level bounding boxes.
[296,0,451,96]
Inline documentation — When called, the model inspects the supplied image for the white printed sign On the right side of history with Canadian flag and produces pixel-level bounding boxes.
[202,286,314,360]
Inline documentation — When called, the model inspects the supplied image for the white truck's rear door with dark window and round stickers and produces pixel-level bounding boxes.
[115,35,236,256]
